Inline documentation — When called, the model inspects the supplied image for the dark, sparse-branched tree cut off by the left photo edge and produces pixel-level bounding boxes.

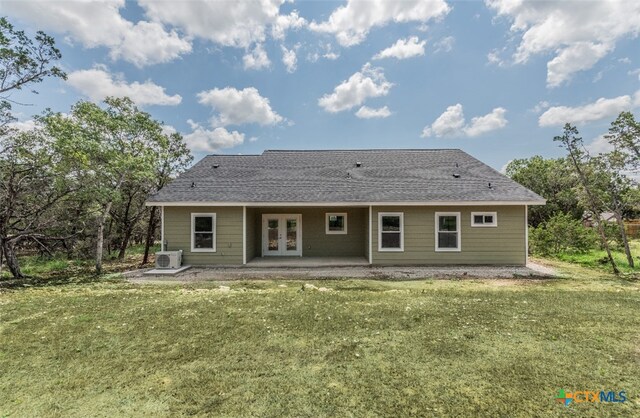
[0,17,66,278]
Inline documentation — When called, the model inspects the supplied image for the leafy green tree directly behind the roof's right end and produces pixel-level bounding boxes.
[506,155,584,227]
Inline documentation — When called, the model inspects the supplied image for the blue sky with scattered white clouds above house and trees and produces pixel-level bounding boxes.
[5,0,640,169]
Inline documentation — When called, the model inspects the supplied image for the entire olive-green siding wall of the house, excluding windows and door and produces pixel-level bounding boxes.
[164,206,526,265]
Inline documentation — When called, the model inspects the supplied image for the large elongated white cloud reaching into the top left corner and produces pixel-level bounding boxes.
[2,0,191,67]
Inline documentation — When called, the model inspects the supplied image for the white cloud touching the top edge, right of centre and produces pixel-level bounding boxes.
[309,0,451,47]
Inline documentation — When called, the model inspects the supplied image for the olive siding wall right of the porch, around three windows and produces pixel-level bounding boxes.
[371,206,526,265]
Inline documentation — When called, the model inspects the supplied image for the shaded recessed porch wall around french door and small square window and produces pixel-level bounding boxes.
[247,207,369,258]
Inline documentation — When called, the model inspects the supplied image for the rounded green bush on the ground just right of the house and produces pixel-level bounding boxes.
[529,213,598,255]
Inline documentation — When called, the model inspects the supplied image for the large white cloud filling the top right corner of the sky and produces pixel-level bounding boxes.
[486,0,640,87]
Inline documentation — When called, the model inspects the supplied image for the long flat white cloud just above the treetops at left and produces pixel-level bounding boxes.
[67,68,182,106]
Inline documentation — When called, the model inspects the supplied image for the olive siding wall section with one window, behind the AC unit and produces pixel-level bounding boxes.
[164,206,242,265]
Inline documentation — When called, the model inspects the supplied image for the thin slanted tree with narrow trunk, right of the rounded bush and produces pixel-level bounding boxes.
[553,123,619,274]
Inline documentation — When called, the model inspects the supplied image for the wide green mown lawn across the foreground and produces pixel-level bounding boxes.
[0,269,640,417]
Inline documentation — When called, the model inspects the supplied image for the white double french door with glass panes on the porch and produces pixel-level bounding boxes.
[262,214,302,256]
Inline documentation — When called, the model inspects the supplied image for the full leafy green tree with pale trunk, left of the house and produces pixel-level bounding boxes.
[47,97,185,274]
